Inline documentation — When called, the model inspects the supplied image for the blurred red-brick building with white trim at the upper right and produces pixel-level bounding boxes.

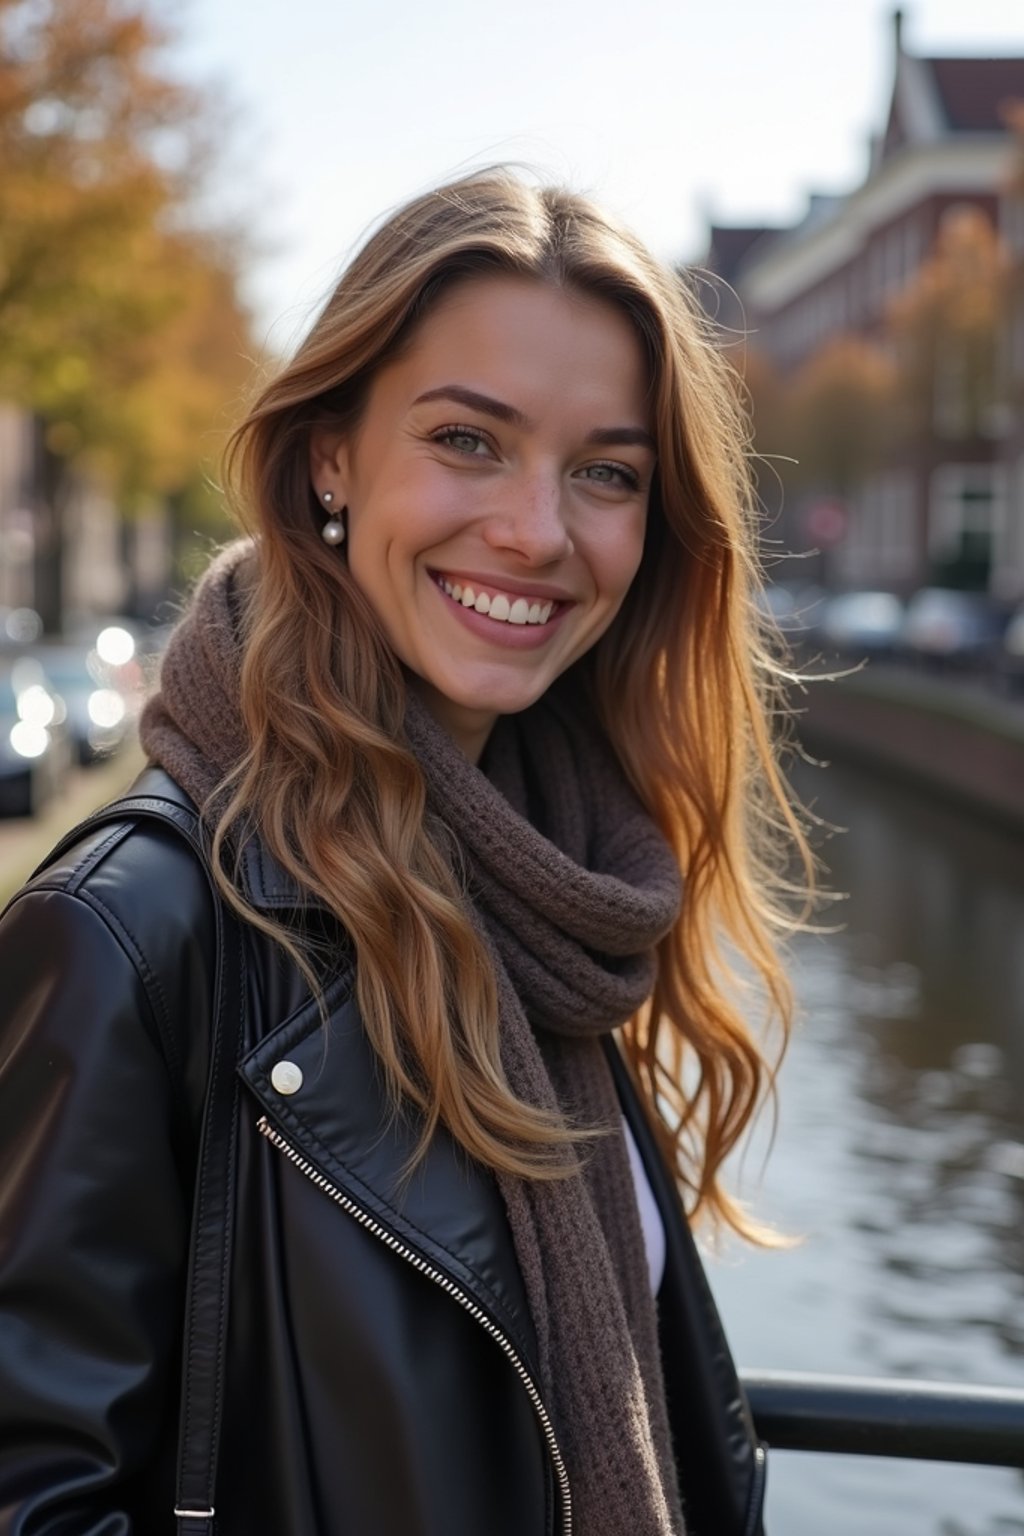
[706,12,1024,598]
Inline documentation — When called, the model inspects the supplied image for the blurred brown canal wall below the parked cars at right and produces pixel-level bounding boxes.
[795,664,1024,833]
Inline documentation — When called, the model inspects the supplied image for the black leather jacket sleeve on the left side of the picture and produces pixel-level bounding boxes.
[0,888,190,1536]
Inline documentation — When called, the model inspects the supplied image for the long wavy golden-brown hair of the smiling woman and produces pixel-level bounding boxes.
[216,170,811,1233]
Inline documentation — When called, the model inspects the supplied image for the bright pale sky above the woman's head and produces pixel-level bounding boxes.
[171,0,1024,349]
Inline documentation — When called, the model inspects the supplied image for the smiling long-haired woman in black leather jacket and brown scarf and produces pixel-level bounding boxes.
[0,174,803,1536]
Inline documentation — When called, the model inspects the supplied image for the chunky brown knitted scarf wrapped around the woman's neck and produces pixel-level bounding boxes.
[141,544,683,1536]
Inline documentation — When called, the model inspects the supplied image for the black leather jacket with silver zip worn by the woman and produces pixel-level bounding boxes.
[0,770,761,1536]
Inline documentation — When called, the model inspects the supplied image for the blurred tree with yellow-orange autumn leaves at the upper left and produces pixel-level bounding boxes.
[0,0,252,622]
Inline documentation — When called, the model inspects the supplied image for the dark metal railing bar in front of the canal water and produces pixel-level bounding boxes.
[740,1370,1024,1467]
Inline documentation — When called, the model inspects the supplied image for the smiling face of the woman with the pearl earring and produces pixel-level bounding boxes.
[312,276,654,762]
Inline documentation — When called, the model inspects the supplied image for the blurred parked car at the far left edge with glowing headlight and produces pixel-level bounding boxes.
[0,653,71,816]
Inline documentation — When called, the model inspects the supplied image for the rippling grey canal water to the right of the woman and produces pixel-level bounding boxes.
[706,766,1024,1536]
